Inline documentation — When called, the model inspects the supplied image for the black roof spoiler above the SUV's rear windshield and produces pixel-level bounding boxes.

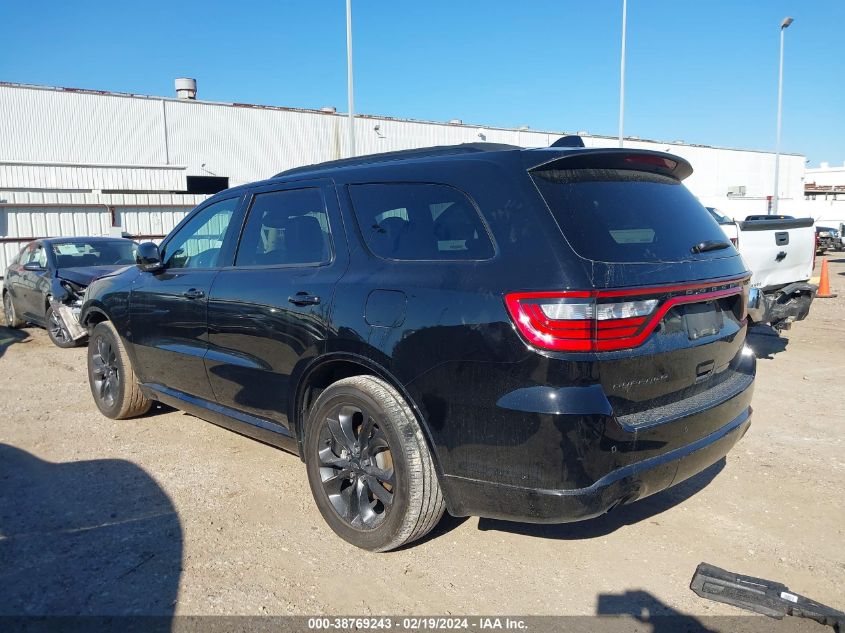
[523,148,692,180]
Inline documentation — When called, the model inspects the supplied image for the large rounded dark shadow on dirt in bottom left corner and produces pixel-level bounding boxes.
[0,444,182,616]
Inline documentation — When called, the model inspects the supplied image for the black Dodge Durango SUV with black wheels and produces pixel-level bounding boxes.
[81,144,755,551]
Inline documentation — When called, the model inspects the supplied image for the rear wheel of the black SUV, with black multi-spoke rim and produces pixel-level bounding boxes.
[305,376,446,552]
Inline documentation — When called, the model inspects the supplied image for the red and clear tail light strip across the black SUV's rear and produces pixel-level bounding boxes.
[505,278,748,352]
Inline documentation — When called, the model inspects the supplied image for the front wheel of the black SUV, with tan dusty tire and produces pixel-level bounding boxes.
[88,321,152,420]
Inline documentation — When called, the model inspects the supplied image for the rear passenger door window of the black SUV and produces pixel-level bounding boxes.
[235,188,331,266]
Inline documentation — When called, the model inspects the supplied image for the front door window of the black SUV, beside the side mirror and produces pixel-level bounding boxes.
[164,198,240,268]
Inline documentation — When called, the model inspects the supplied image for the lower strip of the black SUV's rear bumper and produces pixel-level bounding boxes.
[443,404,751,523]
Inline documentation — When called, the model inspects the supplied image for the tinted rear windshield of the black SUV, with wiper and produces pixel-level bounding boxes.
[531,169,724,262]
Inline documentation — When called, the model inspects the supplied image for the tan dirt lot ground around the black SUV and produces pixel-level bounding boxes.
[0,257,845,630]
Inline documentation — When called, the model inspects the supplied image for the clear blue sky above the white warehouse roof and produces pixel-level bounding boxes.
[0,0,845,165]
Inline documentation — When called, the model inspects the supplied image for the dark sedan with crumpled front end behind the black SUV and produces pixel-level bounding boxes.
[3,237,137,347]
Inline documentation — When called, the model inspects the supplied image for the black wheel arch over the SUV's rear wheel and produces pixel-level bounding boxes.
[288,352,443,478]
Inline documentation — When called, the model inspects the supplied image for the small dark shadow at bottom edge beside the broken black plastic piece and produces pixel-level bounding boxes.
[596,590,714,633]
